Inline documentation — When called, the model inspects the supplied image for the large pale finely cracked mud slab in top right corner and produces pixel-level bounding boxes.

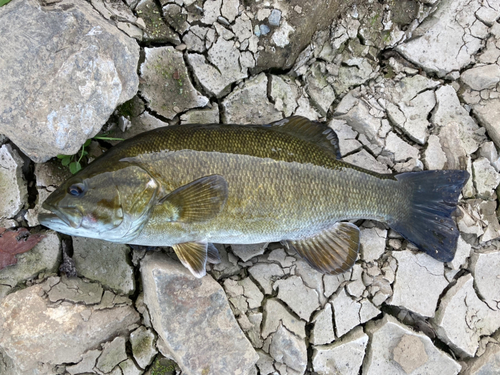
[396,0,486,77]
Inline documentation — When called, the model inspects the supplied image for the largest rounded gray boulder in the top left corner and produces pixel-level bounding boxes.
[0,0,139,162]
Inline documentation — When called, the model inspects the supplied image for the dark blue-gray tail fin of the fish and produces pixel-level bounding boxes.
[388,170,469,262]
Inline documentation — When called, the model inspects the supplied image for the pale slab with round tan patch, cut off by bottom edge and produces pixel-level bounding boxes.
[363,315,461,375]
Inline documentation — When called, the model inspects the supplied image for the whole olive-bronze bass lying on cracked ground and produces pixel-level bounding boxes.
[39,116,469,277]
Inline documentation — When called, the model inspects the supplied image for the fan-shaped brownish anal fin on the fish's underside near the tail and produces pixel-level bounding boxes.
[288,223,359,275]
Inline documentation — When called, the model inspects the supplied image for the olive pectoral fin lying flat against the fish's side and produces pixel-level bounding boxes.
[158,175,227,222]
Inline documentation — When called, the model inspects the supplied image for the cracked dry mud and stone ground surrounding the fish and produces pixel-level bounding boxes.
[0,0,500,375]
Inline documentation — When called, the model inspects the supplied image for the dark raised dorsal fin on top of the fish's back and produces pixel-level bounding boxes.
[269,116,342,159]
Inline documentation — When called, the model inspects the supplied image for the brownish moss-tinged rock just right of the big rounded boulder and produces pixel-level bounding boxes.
[139,47,208,119]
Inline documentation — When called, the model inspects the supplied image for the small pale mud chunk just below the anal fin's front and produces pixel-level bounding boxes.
[273,276,319,321]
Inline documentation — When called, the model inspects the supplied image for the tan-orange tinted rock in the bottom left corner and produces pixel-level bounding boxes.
[0,279,139,373]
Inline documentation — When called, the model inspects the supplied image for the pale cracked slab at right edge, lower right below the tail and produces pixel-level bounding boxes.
[432,274,500,357]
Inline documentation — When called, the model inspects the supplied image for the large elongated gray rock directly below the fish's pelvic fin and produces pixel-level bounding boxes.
[141,254,258,374]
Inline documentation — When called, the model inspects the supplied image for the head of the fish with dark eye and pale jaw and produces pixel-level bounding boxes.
[39,162,159,243]
